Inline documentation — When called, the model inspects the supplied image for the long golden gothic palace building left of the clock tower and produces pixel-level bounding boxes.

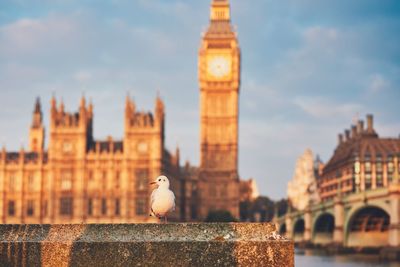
[0,97,180,223]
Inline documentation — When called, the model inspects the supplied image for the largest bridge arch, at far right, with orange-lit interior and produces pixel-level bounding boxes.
[345,205,390,247]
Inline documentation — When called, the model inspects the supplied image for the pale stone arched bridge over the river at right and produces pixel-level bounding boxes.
[274,183,400,248]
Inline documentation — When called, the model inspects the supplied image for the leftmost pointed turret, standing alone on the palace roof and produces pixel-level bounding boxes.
[29,97,44,152]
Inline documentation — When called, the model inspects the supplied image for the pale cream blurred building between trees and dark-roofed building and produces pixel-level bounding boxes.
[287,149,320,210]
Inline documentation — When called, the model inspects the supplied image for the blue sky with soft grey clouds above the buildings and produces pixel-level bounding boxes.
[0,0,400,199]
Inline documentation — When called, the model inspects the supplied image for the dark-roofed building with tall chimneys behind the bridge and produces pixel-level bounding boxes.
[318,115,400,201]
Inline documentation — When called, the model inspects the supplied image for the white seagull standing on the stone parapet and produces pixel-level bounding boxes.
[150,175,175,223]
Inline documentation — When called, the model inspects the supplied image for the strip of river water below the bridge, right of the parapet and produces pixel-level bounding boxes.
[295,250,400,267]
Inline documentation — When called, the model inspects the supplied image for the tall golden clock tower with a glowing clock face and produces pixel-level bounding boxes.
[198,0,240,218]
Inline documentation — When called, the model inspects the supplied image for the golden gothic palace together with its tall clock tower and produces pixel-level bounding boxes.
[0,0,244,223]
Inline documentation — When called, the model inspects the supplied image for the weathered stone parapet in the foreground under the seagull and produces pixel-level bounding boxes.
[0,223,294,267]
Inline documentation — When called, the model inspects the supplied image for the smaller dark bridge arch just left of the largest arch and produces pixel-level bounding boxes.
[312,212,335,244]
